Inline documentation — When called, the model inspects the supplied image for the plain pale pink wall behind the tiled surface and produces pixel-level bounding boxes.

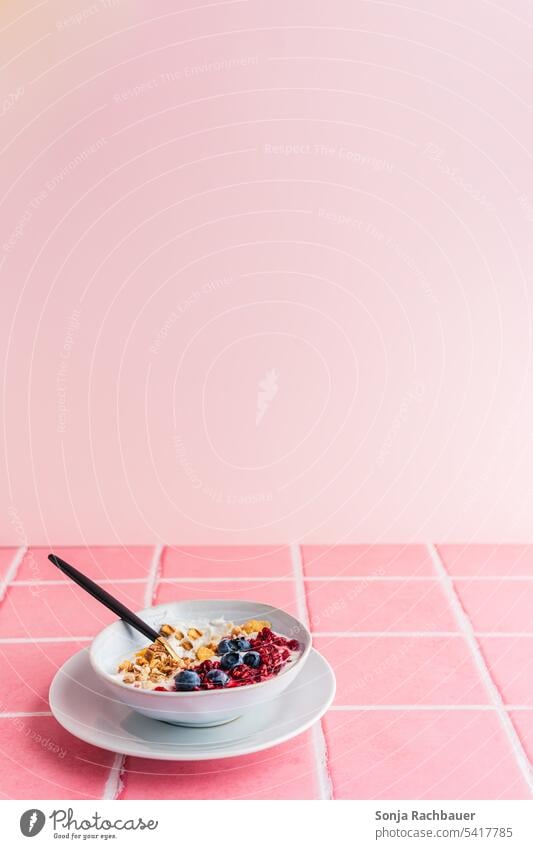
[0,0,533,544]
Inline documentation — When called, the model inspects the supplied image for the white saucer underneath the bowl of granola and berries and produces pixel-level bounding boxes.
[50,649,335,761]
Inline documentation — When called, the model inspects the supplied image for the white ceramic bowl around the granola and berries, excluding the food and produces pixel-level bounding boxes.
[89,599,311,727]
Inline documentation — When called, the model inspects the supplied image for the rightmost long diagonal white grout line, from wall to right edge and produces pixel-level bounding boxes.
[427,543,533,794]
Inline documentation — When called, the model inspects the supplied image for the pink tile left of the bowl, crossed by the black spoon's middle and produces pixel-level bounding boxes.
[0,583,144,637]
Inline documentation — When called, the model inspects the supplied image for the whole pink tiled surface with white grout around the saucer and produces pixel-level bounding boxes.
[0,545,533,799]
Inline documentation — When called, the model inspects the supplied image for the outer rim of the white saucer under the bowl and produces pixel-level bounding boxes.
[48,647,336,762]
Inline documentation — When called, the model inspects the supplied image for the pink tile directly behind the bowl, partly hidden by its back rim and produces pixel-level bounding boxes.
[156,580,296,615]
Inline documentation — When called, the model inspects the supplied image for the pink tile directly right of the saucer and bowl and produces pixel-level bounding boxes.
[314,636,487,705]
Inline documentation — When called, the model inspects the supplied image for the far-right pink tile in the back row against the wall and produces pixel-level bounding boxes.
[437,545,533,578]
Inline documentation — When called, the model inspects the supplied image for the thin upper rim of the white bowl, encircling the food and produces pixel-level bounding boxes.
[89,598,313,699]
